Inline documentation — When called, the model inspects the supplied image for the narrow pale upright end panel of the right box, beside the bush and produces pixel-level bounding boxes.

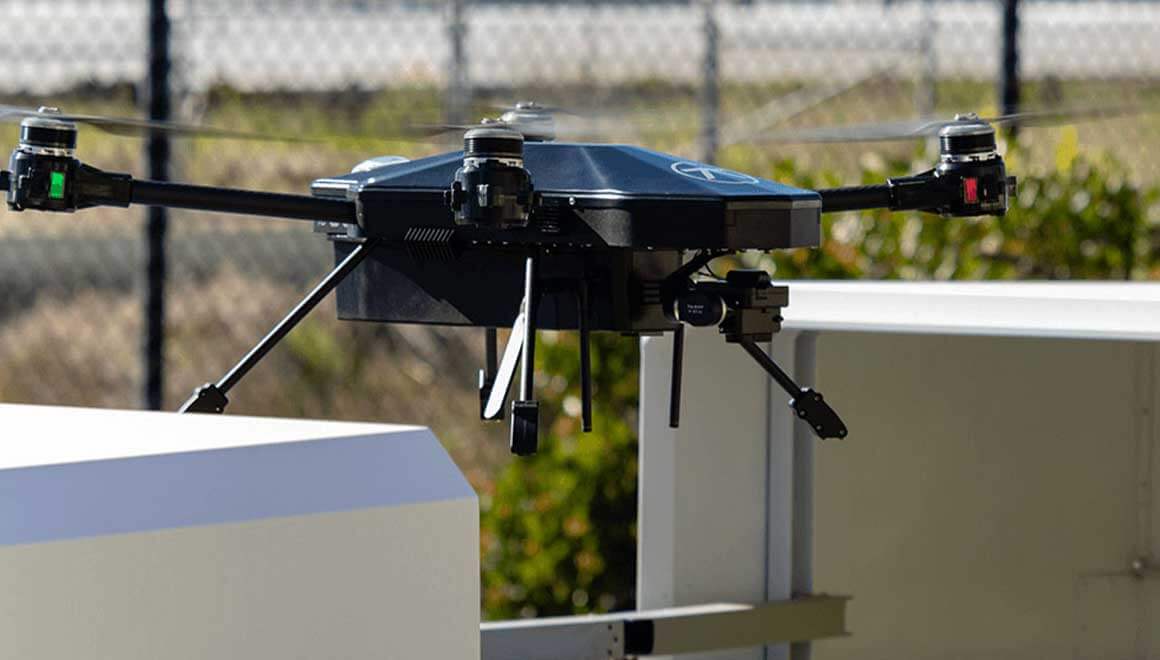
[637,328,807,660]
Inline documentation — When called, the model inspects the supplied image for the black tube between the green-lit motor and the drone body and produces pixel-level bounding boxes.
[130,179,357,224]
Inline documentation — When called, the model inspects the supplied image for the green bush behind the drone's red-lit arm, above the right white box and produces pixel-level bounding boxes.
[756,140,1160,280]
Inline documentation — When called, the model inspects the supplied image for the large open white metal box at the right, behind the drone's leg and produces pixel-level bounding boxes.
[638,282,1160,660]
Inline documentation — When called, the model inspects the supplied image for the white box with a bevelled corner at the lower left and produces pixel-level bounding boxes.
[0,405,479,660]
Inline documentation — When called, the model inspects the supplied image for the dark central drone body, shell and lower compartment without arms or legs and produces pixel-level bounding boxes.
[312,142,821,332]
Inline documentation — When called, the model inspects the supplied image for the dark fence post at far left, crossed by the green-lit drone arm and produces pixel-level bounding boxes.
[142,0,171,411]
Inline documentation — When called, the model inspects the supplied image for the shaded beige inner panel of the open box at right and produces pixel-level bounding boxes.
[814,333,1160,660]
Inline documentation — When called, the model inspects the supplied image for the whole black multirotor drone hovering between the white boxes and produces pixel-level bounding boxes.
[0,103,1095,456]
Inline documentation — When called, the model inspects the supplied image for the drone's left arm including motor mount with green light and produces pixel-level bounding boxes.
[0,159,357,224]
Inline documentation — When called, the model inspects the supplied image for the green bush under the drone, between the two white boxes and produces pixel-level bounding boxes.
[480,333,638,618]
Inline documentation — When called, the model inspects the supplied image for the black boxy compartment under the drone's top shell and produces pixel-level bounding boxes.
[334,240,680,332]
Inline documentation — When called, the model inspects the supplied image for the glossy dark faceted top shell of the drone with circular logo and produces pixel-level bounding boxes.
[312,142,821,249]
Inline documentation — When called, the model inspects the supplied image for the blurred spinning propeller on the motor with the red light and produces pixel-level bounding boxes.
[747,106,1154,143]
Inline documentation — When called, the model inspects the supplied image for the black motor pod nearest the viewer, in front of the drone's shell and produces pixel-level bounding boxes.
[447,125,538,229]
